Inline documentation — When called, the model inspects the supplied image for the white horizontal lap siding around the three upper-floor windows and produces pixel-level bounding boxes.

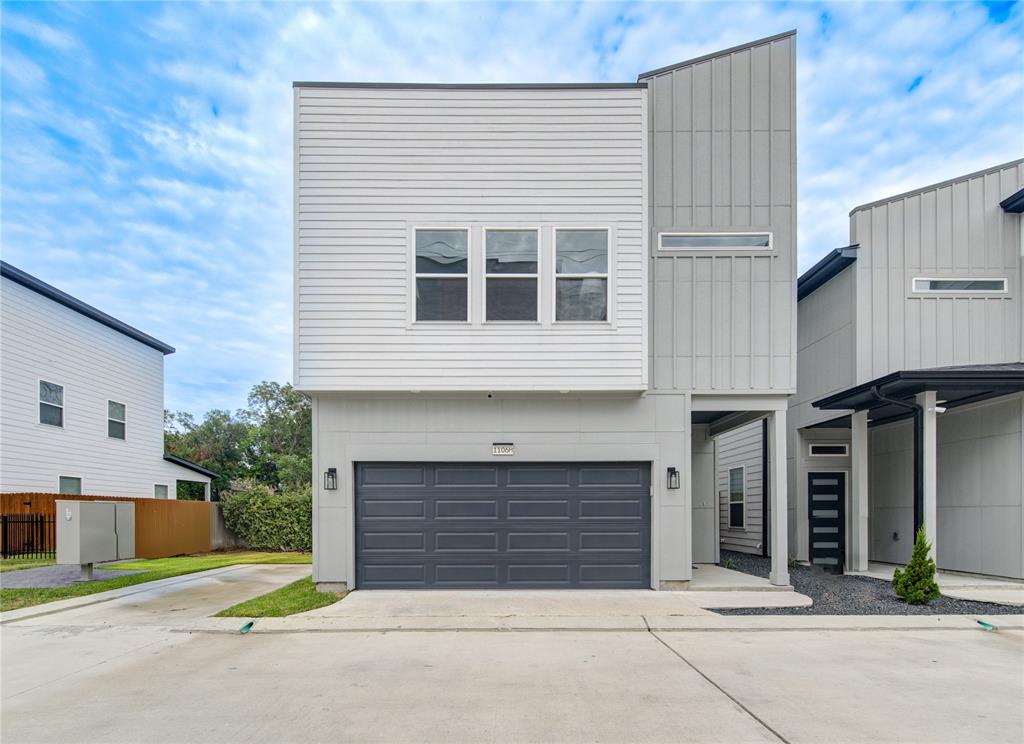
[295,88,646,391]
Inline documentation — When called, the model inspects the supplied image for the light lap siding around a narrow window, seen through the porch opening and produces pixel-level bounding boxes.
[715,421,764,555]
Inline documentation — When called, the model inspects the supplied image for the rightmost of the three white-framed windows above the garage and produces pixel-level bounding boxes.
[554,227,609,322]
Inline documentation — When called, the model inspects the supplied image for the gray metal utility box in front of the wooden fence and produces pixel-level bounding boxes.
[56,500,135,566]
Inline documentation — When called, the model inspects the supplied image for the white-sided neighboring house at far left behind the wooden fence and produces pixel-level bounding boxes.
[0,262,216,499]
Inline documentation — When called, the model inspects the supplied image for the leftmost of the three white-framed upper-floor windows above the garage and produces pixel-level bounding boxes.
[414,227,469,322]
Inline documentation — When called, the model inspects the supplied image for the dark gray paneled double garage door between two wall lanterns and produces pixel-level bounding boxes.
[355,463,650,588]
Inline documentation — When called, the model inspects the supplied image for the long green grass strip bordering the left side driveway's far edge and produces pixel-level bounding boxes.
[0,551,312,611]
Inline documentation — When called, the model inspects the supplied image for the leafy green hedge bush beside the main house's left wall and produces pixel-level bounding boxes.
[221,483,313,551]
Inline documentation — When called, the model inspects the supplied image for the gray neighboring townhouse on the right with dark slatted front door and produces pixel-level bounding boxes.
[717,161,1024,578]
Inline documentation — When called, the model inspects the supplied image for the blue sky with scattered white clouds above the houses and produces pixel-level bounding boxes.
[0,3,1024,413]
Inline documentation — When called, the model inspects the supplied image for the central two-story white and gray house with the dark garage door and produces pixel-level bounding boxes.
[294,32,797,589]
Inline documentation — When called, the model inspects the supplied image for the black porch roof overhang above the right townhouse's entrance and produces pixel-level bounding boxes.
[812,362,1024,424]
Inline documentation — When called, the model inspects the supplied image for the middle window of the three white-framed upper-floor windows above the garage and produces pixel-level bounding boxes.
[483,228,541,322]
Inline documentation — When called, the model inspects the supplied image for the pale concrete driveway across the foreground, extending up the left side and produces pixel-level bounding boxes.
[0,566,1024,744]
